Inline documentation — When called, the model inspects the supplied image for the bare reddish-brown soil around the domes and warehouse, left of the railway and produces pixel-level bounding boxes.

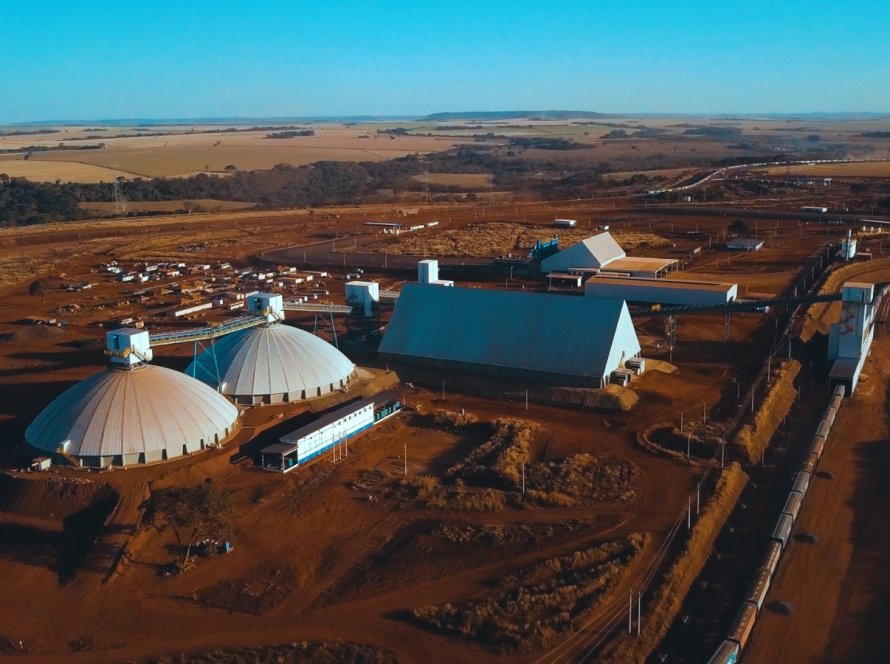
[0,167,874,662]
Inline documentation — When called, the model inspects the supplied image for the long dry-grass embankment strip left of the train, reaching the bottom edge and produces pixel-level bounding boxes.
[596,463,748,664]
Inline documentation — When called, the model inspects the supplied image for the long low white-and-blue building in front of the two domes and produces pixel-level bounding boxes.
[260,390,403,473]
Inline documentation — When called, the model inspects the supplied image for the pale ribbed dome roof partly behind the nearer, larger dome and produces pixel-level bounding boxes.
[186,323,355,397]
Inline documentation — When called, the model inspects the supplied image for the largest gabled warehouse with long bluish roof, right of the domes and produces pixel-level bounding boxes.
[379,284,640,387]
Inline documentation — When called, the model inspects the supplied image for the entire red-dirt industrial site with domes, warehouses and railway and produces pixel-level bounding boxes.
[0,156,890,663]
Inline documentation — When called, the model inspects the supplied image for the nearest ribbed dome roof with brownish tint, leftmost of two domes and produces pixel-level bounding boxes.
[25,365,238,457]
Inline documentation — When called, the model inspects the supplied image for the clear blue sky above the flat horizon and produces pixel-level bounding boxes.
[0,0,890,123]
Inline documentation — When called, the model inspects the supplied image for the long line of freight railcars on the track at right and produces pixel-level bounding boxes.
[708,385,845,664]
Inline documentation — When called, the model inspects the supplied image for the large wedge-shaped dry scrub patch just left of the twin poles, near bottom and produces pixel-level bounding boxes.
[414,533,649,651]
